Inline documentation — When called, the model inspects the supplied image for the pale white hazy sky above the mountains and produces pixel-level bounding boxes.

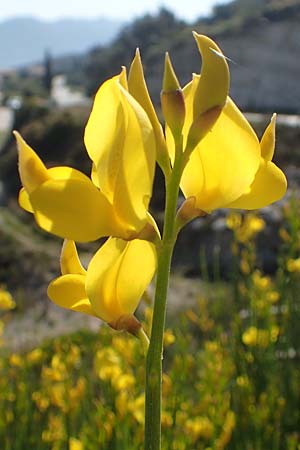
[0,0,229,20]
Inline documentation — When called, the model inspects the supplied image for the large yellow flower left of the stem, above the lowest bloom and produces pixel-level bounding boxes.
[15,69,156,242]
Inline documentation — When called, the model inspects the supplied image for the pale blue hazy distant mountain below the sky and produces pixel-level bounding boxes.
[0,17,123,69]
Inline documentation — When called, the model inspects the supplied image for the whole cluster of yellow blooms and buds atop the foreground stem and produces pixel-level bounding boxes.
[15,33,286,331]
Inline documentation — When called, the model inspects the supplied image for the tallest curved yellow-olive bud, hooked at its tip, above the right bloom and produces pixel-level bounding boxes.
[194,32,229,118]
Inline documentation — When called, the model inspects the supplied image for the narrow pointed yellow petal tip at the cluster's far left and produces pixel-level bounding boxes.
[14,131,49,194]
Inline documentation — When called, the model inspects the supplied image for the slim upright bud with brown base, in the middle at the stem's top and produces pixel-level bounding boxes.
[160,53,185,136]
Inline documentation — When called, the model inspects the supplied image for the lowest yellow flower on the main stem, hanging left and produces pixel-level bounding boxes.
[48,238,156,329]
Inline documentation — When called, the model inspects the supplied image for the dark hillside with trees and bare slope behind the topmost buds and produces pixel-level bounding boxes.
[78,0,300,113]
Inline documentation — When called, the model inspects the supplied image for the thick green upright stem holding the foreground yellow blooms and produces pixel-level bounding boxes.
[144,140,183,450]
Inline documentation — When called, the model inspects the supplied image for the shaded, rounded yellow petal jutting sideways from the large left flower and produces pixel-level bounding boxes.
[30,178,120,242]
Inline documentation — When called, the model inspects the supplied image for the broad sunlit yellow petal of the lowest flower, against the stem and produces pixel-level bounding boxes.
[86,238,156,323]
